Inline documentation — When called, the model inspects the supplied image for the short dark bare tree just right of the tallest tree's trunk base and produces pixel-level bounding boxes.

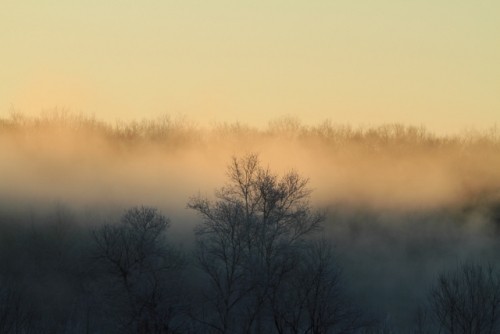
[272,239,366,334]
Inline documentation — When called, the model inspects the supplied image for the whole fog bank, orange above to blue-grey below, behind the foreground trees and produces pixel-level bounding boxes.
[0,113,500,332]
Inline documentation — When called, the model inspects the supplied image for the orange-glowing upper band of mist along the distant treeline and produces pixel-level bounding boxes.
[0,113,500,209]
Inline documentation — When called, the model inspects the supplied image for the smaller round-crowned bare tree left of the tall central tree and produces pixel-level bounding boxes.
[93,207,183,333]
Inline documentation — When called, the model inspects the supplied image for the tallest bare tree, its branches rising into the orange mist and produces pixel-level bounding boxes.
[188,155,323,333]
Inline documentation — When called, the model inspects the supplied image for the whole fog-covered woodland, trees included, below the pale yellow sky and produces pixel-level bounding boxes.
[0,111,500,333]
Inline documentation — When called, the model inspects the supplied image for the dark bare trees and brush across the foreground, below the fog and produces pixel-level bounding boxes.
[0,155,500,333]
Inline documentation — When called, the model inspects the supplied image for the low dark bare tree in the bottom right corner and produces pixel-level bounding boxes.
[431,264,500,334]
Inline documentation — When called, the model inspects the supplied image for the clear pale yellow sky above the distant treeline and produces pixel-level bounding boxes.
[0,0,500,131]
